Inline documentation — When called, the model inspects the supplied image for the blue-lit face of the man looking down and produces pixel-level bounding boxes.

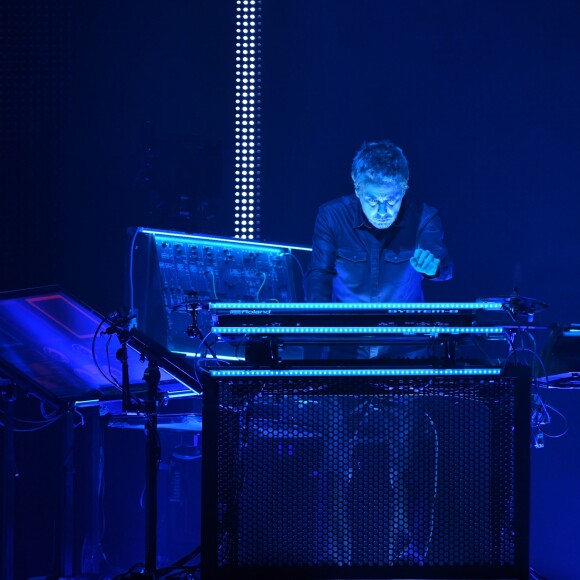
[356,181,405,230]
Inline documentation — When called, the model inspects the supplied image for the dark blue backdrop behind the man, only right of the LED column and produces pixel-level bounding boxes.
[262,0,580,320]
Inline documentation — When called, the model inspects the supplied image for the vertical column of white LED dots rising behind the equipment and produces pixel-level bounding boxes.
[234,0,261,240]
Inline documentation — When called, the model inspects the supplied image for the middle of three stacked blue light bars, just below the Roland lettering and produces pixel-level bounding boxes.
[211,326,504,334]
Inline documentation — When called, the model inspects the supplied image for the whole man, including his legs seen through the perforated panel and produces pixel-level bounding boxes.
[305,141,453,564]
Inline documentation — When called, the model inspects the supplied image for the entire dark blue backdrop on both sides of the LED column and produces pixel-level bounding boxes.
[0,0,580,580]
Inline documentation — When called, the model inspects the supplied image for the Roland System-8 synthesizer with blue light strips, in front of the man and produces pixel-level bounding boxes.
[206,302,506,366]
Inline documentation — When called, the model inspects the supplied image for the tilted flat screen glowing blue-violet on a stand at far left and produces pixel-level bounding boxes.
[0,286,201,575]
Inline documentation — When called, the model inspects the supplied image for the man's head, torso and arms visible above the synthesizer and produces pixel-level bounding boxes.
[305,141,453,303]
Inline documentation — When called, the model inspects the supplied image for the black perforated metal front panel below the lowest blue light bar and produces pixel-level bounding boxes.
[203,376,529,578]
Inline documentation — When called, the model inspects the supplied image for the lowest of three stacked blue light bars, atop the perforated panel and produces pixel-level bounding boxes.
[210,368,501,378]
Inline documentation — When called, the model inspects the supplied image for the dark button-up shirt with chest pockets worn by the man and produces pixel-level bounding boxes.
[305,195,453,303]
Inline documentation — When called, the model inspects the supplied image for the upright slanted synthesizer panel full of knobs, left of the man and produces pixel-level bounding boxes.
[128,228,310,353]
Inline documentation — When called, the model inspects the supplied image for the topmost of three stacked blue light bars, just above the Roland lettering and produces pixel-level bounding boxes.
[209,302,503,314]
